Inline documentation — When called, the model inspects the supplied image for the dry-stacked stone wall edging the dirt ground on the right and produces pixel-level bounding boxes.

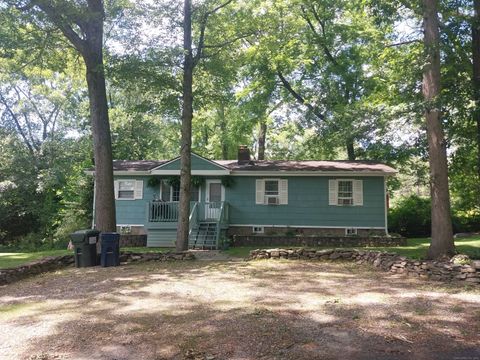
[250,249,480,285]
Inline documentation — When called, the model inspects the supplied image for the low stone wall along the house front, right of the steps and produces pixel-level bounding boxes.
[233,235,407,247]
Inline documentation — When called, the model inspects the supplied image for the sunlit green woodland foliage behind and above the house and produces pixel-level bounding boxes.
[0,0,480,256]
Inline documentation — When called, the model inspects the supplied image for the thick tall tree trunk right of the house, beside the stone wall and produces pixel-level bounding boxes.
[423,0,455,259]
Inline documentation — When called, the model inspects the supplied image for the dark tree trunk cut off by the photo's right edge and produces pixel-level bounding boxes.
[472,0,480,191]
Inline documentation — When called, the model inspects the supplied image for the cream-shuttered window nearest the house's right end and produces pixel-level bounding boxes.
[328,179,363,206]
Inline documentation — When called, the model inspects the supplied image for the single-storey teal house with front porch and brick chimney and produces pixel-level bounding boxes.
[88,147,396,248]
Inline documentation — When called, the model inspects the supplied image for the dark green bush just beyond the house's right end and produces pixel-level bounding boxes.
[388,195,432,237]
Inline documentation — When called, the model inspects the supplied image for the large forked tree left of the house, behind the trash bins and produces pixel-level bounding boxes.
[17,0,116,231]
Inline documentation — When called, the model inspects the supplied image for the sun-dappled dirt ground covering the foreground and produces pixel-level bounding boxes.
[0,260,480,360]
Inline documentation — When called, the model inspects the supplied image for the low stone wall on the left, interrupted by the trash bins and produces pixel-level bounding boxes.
[0,252,195,285]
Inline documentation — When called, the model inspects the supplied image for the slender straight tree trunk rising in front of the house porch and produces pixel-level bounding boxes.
[176,0,194,251]
